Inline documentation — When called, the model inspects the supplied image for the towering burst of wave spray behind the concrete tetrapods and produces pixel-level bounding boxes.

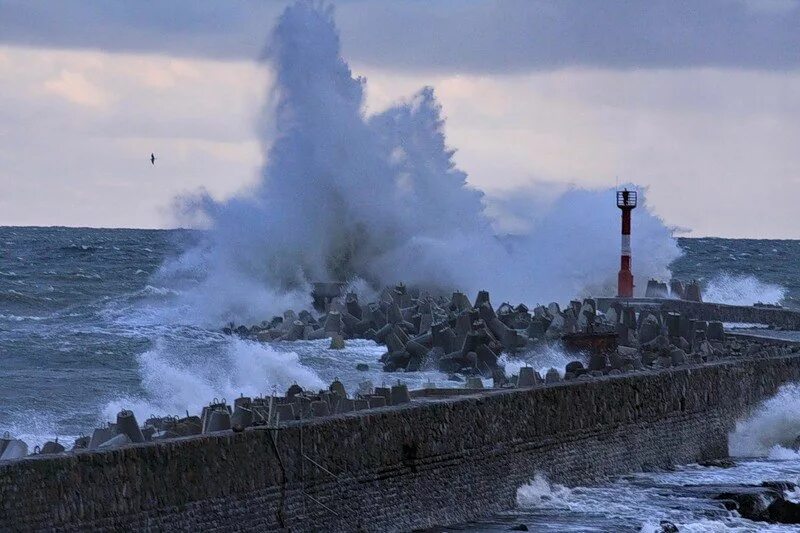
[161,2,679,323]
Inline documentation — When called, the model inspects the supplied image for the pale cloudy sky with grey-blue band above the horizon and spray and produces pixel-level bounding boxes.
[0,0,800,238]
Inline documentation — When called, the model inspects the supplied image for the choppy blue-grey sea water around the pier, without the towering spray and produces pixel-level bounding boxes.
[0,227,800,532]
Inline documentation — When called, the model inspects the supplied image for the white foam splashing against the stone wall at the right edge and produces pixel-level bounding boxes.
[729,384,800,459]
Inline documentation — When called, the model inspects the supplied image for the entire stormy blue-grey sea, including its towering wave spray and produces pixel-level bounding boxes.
[0,2,800,532]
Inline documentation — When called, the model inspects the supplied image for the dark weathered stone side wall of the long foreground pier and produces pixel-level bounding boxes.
[0,353,800,531]
